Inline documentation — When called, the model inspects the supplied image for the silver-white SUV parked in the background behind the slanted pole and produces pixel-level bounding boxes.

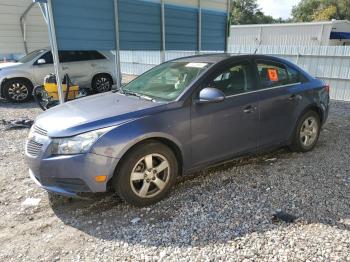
[0,49,116,103]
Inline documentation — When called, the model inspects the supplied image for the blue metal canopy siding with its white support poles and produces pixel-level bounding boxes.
[33,0,230,103]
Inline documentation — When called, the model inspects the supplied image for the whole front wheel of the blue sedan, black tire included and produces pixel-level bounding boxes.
[112,141,178,207]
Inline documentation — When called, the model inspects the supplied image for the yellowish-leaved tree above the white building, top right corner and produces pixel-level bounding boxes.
[292,0,350,22]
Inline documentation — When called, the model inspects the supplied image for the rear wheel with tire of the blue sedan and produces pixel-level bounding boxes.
[290,111,321,152]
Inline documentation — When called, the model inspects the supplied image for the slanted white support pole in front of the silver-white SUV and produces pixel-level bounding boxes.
[45,0,64,104]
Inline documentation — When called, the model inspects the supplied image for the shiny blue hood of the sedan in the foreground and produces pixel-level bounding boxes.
[35,92,166,137]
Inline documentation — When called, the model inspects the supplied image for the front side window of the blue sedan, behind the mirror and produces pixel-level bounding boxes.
[209,62,253,96]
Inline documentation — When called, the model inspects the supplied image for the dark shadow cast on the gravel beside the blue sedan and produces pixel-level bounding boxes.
[51,140,350,247]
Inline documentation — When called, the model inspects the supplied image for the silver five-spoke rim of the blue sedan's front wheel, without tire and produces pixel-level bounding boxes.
[130,154,171,198]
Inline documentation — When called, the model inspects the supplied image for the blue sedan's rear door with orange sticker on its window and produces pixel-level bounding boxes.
[255,60,302,148]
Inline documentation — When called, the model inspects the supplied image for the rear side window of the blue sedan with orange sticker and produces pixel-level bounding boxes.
[257,61,305,88]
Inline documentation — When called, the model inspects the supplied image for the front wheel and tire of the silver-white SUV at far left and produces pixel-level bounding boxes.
[3,79,33,103]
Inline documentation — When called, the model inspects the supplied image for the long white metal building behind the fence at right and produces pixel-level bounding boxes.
[229,20,350,46]
